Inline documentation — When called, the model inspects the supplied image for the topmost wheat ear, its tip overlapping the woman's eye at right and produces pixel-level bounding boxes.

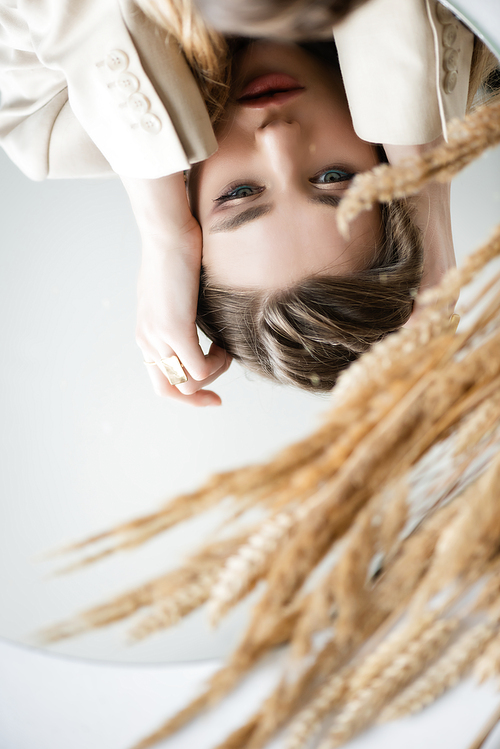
[337,102,500,236]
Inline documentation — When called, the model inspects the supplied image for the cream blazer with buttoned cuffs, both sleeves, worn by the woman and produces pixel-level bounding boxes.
[0,0,473,180]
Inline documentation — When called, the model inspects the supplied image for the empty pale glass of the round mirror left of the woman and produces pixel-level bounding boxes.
[0,146,327,661]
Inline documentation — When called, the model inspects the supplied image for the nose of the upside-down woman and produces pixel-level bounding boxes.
[255,119,304,185]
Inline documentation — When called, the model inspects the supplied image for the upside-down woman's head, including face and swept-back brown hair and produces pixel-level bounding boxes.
[190,42,442,390]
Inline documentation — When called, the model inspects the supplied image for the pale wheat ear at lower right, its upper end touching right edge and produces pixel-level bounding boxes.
[380,622,500,722]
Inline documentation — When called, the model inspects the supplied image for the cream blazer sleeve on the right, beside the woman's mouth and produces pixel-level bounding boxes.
[333,0,474,145]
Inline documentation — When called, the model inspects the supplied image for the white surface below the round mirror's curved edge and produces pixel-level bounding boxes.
[0,641,500,749]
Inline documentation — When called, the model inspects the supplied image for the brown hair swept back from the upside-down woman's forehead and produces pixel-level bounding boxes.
[197,200,422,391]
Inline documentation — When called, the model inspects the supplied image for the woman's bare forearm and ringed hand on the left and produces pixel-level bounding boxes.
[124,175,231,406]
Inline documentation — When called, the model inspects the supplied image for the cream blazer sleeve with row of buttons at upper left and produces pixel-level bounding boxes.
[0,0,217,180]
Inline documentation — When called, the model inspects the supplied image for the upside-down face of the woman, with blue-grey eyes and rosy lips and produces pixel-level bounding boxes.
[191,42,381,289]
